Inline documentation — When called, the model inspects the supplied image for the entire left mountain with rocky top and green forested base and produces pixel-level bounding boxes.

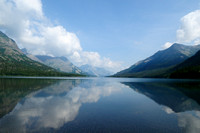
[0,31,82,76]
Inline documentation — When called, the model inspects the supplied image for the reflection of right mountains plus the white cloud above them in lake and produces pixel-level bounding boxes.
[123,82,200,133]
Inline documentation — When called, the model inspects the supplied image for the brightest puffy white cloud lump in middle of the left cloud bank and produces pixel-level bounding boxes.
[20,25,82,56]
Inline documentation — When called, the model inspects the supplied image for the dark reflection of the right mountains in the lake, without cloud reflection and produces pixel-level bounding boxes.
[123,82,200,112]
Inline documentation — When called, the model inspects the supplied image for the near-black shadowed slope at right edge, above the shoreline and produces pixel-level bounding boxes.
[170,50,200,79]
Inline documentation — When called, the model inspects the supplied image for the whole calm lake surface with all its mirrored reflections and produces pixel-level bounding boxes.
[0,78,200,133]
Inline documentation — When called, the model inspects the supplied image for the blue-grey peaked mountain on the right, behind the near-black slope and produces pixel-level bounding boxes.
[114,43,200,77]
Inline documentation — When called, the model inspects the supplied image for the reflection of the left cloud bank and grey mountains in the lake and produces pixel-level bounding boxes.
[0,80,120,132]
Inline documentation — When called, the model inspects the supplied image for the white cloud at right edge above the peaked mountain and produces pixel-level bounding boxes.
[177,10,200,44]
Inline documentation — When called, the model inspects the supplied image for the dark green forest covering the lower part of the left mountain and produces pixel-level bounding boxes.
[0,48,84,76]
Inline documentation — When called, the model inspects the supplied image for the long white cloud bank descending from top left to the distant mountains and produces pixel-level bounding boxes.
[0,0,121,71]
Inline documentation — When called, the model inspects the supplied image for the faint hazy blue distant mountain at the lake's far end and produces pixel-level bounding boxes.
[79,64,112,77]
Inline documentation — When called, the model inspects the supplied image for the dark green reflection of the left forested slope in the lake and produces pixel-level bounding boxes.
[0,78,57,118]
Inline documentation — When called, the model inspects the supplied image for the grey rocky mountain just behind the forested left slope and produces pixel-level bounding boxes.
[35,55,84,74]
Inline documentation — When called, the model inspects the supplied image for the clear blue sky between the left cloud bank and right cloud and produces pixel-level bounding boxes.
[42,0,200,66]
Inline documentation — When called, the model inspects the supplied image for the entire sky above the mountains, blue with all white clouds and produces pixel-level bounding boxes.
[0,0,200,72]
